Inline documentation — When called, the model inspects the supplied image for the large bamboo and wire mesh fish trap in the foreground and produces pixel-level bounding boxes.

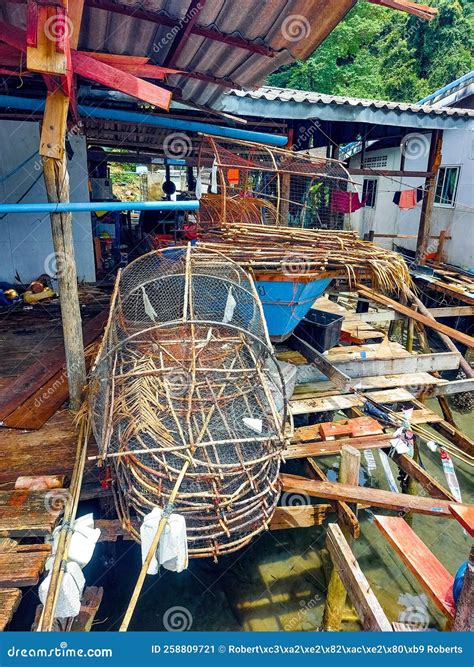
[89,246,287,557]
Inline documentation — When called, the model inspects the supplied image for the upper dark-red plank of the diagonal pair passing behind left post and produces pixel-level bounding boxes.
[0,309,108,428]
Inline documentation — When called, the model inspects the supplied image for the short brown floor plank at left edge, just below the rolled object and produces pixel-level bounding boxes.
[0,489,65,537]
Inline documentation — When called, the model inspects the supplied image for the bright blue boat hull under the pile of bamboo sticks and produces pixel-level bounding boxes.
[255,278,332,342]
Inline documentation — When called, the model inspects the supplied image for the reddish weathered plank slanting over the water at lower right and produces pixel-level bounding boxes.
[375,516,455,619]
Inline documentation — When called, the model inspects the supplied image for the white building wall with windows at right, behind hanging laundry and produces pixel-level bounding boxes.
[349,130,474,269]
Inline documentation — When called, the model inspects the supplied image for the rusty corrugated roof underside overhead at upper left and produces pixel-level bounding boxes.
[0,0,356,105]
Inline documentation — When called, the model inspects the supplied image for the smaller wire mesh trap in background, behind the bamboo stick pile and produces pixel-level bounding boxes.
[198,136,357,229]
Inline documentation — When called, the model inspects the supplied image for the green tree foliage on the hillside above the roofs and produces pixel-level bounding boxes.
[268,0,474,102]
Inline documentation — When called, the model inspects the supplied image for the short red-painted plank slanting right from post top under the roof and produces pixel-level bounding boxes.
[71,51,172,111]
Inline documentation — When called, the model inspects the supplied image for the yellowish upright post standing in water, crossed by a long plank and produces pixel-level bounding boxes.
[323,445,360,632]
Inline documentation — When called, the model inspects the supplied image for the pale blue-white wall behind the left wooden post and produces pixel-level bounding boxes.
[0,120,95,283]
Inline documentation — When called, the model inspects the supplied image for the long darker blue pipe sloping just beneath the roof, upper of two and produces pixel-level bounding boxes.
[0,95,288,146]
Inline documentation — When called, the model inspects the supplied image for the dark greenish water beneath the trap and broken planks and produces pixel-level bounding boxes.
[86,405,474,631]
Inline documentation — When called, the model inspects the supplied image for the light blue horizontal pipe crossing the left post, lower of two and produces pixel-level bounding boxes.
[0,199,199,213]
